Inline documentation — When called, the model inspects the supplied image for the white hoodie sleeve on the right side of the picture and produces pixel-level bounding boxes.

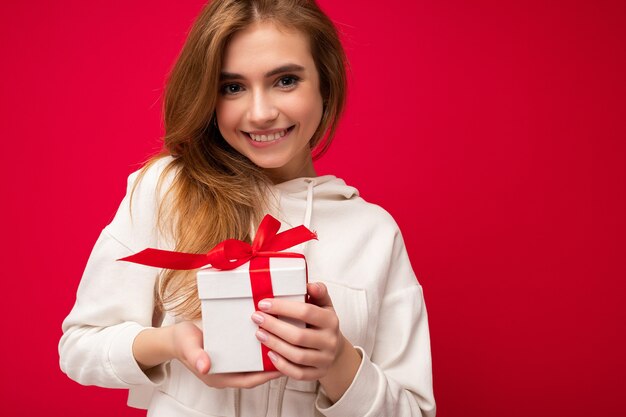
[316,228,435,417]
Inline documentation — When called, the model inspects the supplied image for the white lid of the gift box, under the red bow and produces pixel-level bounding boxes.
[197,258,306,300]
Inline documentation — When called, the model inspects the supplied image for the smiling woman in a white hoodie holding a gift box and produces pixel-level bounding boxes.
[59,0,434,416]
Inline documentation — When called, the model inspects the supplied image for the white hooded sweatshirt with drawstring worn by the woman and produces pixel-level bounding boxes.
[59,157,435,417]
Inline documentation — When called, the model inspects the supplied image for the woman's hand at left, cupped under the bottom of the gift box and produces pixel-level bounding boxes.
[172,321,281,388]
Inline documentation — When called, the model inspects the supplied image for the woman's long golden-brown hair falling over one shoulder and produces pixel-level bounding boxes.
[140,0,346,319]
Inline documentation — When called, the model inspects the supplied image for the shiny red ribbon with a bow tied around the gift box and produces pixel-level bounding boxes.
[118,214,317,371]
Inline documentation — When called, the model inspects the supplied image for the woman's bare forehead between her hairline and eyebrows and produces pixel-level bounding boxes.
[222,21,315,74]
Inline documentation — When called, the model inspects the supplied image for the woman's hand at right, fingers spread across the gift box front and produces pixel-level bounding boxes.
[247,283,360,384]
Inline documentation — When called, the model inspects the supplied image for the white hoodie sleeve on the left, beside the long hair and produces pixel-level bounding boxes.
[59,162,171,388]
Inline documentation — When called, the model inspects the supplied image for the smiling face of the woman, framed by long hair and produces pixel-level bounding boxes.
[216,22,323,182]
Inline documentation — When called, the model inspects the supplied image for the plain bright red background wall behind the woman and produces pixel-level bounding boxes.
[0,0,626,417]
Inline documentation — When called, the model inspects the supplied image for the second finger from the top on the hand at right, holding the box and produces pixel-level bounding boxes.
[252,311,331,350]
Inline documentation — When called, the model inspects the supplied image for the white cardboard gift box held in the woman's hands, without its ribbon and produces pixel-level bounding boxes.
[197,257,307,374]
